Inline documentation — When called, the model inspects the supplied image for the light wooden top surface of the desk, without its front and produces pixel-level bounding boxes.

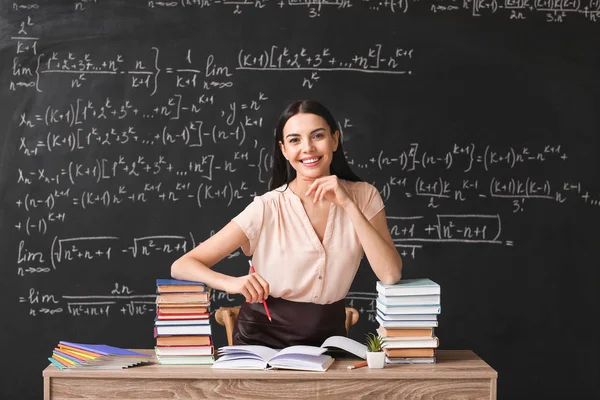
[42,349,498,380]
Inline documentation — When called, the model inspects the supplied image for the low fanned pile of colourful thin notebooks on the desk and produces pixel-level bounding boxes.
[48,341,151,369]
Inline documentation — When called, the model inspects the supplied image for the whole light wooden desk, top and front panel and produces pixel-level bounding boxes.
[42,350,498,400]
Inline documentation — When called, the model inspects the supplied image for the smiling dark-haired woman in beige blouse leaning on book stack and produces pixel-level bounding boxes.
[171,101,402,348]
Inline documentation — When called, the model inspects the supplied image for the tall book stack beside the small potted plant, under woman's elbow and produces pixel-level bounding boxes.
[375,278,441,364]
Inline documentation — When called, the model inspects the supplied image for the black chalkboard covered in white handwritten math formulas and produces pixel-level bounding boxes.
[0,0,600,399]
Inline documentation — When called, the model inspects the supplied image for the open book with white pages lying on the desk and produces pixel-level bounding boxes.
[212,336,367,371]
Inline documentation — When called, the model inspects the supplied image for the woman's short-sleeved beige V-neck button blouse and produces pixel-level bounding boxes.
[233,180,384,304]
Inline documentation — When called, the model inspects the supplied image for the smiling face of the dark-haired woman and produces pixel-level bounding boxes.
[279,113,340,179]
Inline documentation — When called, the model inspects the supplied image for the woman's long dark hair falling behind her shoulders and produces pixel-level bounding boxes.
[269,100,361,190]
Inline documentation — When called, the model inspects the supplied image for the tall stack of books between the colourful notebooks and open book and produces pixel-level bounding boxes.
[154,279,214,364]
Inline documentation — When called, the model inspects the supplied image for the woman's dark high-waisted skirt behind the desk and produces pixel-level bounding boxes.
[233,297,346,349]
